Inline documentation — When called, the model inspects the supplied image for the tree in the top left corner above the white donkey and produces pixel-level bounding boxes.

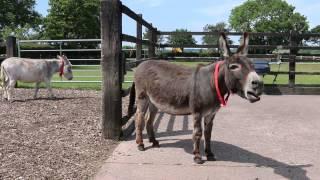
[0,0,42,39]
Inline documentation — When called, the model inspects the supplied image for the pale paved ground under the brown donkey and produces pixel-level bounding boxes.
[95,95,320,180]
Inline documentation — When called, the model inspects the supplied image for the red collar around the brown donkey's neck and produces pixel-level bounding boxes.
[211,61,230,107]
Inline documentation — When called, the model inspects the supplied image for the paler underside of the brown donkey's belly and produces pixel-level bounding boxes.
[149,97,191,115]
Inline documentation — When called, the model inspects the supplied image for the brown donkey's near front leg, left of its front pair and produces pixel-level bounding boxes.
[192,113,203,164]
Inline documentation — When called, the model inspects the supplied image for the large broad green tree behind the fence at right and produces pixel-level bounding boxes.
[229,0,309,44]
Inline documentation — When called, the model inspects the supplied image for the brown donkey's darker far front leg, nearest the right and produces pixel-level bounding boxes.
[204,114,216,161]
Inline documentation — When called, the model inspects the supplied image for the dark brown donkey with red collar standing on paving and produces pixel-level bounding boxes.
[129,33,263,164]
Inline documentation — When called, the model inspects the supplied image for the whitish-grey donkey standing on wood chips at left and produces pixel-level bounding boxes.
[0,55,73,101]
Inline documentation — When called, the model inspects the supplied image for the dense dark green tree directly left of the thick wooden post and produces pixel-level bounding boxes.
[44,0,100,39]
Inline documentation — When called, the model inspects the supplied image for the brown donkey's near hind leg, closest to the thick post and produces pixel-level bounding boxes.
[135,95,149,151]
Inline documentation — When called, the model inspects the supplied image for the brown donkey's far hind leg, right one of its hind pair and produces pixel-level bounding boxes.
[147,102,159,147]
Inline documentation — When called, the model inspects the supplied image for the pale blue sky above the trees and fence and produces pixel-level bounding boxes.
[36,0,320,43]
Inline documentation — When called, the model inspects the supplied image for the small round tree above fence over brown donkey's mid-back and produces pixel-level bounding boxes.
[167,29,197,51]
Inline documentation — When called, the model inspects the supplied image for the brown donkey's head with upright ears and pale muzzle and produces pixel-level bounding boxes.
[219,33,263,102]
